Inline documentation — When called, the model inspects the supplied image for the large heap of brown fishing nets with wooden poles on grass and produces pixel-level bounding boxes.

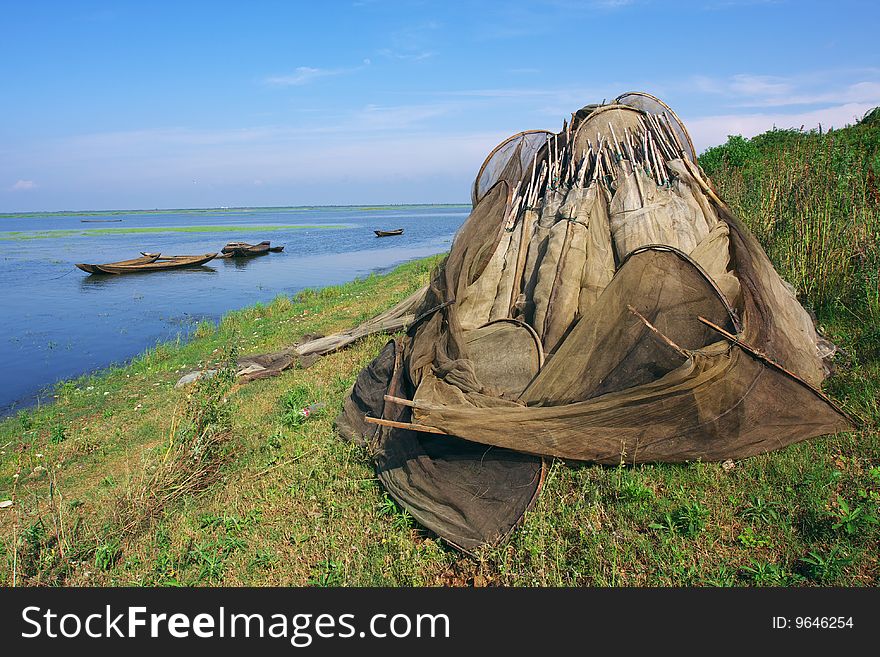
[330,93,851,550]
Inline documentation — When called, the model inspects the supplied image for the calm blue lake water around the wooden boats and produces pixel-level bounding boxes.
[0,206,470,415]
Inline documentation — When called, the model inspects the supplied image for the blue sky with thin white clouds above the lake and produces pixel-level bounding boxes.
[0,0,880,212]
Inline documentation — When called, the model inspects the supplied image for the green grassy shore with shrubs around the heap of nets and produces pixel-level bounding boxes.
[0,115,880,586]
